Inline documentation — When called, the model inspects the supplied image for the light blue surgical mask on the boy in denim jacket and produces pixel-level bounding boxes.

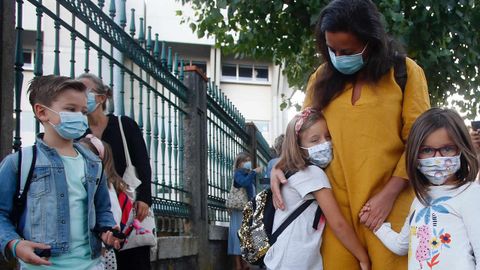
[45,107,88,140]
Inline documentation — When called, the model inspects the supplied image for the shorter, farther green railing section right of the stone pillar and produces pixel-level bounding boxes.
[207,82,271,222]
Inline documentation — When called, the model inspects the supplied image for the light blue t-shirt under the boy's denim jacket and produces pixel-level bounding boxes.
[22,152,100,270]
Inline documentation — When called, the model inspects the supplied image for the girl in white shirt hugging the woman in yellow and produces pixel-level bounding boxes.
[264,108,370,270]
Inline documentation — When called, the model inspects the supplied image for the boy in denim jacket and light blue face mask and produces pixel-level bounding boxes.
[0,75,120,269]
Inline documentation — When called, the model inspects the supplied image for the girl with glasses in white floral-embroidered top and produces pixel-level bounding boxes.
[360,108,480,270]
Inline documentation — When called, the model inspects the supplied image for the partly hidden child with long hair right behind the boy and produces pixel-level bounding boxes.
[80,134,127,270]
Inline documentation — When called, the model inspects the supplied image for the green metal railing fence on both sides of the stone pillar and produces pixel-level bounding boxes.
[13,0,269,228]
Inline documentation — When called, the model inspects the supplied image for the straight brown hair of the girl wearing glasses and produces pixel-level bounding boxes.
[406,108,478,205]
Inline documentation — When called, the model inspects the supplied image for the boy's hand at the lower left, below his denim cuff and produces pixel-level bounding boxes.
[8,240,52,265]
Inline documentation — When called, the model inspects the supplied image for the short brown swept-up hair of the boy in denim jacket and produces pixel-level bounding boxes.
[27,75,86,112]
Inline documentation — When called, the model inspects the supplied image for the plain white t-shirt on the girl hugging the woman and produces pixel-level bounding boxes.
[264,165,331,270]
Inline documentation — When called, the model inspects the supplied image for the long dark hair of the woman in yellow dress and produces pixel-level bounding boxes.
[313,0,404,110]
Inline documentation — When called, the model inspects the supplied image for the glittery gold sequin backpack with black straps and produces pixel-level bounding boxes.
[238,173,322,265]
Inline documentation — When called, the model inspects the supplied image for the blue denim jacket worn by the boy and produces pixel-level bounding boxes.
[0,136,115,258]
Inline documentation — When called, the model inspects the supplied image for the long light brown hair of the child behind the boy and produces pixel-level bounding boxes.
[79,138,127,194]
